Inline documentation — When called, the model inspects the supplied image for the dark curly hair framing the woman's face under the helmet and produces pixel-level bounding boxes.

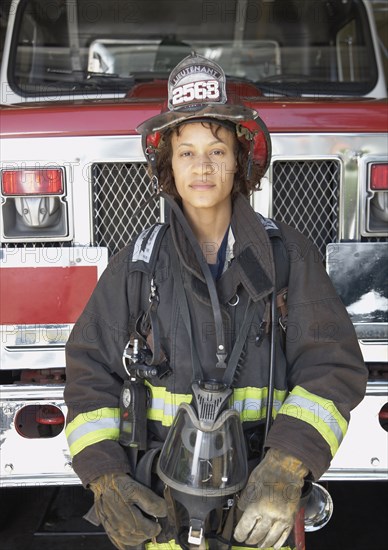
[152,120,263,199]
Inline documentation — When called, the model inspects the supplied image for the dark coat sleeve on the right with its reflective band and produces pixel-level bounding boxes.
[266,227,367,479]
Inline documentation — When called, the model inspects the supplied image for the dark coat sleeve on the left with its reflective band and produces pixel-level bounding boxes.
[64,249,140,486]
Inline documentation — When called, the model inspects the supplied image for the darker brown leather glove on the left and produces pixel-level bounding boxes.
[90,474,167,550]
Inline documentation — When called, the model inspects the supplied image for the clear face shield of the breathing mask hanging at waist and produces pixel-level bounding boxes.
[158,403,248,498]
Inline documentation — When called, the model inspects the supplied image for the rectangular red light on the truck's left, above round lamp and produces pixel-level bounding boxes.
[1,168,63,196]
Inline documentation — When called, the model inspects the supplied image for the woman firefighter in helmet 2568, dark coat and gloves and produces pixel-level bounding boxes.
[65,53,367,550]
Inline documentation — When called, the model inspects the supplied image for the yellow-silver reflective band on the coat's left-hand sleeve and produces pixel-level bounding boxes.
[65,407,120,456]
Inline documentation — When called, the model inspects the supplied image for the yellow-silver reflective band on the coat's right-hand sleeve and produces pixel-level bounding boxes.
[279,386,348,456]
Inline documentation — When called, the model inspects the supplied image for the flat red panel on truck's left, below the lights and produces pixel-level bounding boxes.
[0,266,97,325]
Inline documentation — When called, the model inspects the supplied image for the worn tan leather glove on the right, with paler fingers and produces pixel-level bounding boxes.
[234,449,308,550]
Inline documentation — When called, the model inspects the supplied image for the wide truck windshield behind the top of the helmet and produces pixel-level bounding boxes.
[8,0,377,97]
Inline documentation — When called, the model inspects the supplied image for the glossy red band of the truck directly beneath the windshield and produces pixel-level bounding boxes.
[0,97,388,138]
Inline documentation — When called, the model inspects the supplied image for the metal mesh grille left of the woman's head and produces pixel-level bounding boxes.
[92,163,160,254]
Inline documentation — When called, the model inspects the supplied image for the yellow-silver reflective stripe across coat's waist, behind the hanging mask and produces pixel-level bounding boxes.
[146,381,288,426]
